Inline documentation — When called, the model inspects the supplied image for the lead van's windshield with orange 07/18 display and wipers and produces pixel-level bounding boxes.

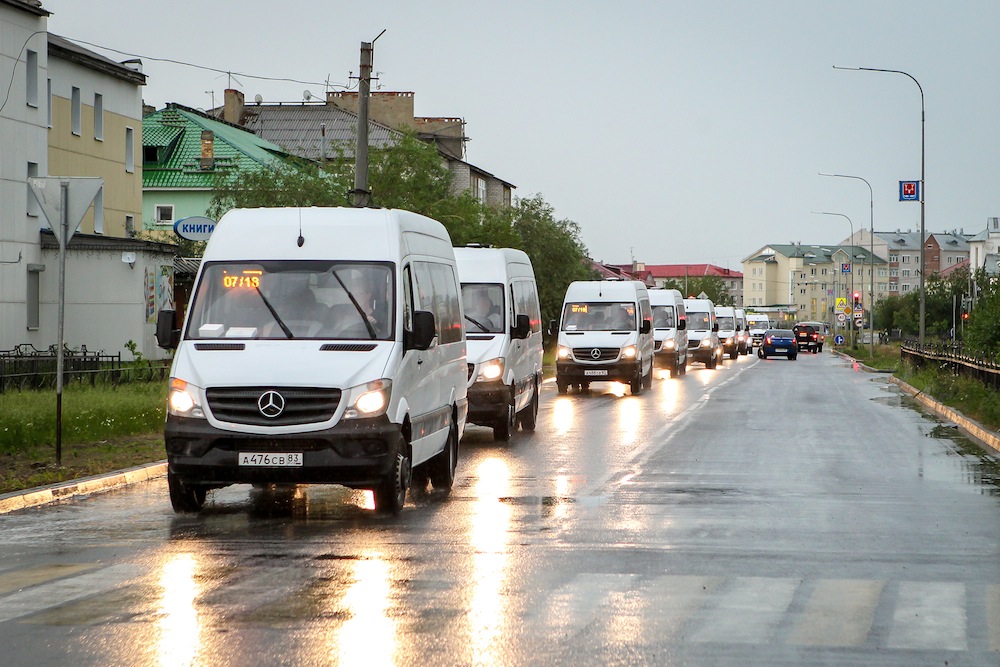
[187,260,395,340]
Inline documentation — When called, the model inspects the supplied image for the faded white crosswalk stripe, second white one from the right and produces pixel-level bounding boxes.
[691,577,799,644]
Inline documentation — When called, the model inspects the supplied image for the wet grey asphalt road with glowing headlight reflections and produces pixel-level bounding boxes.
[0,354,1000,666]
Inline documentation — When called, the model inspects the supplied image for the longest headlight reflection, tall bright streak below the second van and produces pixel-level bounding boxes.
[469,458,512,665]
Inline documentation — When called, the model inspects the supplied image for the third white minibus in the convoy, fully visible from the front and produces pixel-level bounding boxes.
[550,280,653,394]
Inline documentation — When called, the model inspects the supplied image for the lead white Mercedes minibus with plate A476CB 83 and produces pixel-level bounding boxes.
[157,208,467,513]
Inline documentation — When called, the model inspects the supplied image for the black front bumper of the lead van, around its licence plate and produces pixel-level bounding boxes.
[164,415,405,489]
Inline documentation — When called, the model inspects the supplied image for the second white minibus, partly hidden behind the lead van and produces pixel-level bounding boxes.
[455,246,542,441]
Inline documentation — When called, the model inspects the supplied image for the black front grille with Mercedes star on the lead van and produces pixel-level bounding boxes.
[205,387,340,426]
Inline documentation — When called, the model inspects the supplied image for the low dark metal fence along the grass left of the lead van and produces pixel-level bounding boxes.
[0,343,169,394]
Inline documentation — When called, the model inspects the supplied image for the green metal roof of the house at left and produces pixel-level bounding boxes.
[142,104,290,189]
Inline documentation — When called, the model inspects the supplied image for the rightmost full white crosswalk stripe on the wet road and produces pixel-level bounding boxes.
[888,581,968,651]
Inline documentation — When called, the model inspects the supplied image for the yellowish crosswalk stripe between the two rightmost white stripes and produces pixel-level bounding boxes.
[788,579,883,646]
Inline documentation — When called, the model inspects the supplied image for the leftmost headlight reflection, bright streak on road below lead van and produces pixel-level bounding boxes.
[157,554,201,667]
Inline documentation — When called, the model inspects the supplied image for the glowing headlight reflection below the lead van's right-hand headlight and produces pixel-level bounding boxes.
[333,553,397,667]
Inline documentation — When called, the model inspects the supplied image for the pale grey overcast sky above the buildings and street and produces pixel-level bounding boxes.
[43,0,1000,269]
